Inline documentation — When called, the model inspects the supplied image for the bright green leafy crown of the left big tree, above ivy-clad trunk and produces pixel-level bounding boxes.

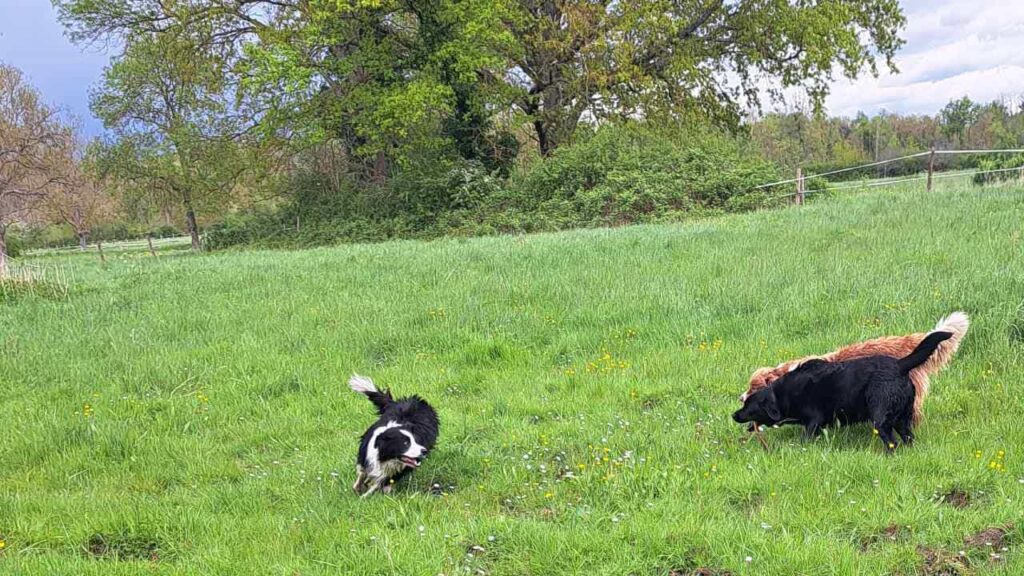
[54,0,511,181]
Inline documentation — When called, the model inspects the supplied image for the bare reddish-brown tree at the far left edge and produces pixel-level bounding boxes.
[0,63,66,277]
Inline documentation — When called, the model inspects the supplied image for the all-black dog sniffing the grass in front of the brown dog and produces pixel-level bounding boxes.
[732,332,952,452]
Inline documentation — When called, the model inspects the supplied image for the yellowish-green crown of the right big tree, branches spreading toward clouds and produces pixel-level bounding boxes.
[507,0,904,154]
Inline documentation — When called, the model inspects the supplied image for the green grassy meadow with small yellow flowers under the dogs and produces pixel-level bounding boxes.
[0,183,1024,576]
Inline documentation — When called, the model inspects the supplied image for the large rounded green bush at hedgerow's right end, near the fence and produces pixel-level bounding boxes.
[512,124,778,225]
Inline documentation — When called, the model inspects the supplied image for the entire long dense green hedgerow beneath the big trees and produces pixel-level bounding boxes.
[205,124,779,249]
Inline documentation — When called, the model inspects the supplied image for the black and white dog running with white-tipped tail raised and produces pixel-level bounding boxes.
[348,374,440,496]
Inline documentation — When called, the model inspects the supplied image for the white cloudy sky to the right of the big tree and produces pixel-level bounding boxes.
[825,0,1024,116]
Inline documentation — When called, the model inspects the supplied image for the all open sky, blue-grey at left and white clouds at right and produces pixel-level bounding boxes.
[0,0,1024,133]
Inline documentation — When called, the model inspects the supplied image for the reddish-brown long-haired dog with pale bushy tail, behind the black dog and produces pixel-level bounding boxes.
[739,312,971,425]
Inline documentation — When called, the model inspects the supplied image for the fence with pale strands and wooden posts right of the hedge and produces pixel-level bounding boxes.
[751,149,1024,204]
